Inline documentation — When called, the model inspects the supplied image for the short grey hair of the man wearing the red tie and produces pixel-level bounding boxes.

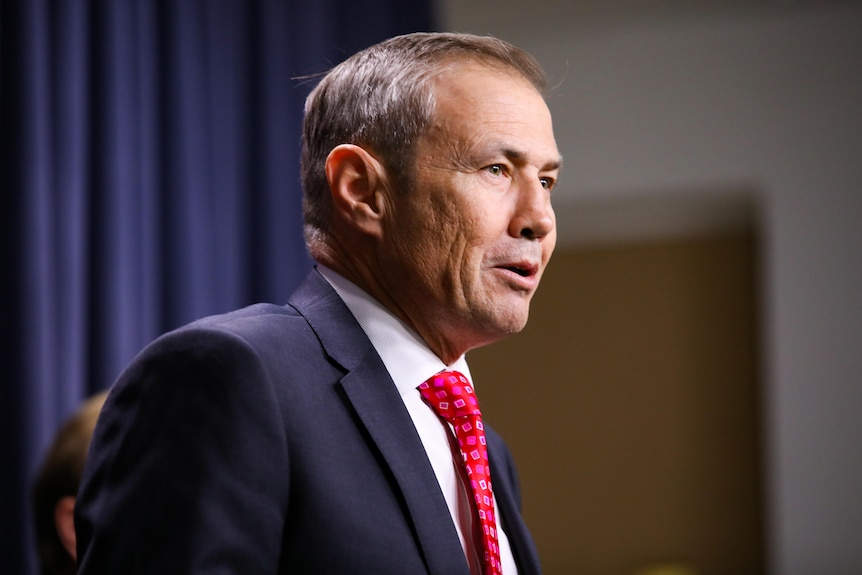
[301,33,547,255]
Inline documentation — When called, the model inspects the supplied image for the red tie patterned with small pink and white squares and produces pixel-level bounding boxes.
[419,371,503,575]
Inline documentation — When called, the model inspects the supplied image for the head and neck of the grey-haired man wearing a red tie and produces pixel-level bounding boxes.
[303,34,560,360]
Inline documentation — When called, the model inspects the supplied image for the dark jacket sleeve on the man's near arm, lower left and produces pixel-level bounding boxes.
[75,329,289,575]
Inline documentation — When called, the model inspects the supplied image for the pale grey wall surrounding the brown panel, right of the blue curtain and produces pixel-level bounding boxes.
[438,4,862,575]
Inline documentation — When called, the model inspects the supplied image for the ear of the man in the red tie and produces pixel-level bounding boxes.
[326,144,386,236]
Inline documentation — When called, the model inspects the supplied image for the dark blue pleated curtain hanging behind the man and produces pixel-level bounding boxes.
[0,0,433,574]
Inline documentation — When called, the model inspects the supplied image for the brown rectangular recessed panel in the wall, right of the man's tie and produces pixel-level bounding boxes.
[469,237,764,575]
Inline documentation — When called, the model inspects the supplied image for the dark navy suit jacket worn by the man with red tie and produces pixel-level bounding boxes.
[75,271,539,575]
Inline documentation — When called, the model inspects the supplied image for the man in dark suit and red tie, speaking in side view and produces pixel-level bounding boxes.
[76,34,561,575]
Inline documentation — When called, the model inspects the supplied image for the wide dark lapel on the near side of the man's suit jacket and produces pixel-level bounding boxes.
[291,271,469,575]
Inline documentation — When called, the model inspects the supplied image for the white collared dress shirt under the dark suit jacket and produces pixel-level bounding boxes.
[318,264,518,575]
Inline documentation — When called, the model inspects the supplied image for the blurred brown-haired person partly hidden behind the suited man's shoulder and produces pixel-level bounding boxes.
[32,391,108,575]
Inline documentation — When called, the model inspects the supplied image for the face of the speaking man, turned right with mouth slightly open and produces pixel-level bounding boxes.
[380,65,560,360]
